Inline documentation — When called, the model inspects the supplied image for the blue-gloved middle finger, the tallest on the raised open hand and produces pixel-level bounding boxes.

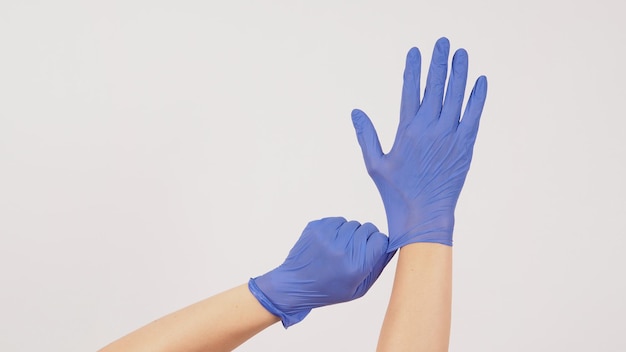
[418,38,450,122]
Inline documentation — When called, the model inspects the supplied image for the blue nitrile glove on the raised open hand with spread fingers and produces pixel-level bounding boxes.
[352,38,487,251]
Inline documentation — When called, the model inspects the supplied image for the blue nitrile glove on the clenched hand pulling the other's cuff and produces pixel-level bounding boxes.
[248,217,393,328]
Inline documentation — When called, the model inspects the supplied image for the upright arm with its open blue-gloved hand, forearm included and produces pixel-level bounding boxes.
[352,38,487,352]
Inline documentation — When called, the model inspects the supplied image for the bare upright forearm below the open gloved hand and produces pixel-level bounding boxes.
[377,243,452,352]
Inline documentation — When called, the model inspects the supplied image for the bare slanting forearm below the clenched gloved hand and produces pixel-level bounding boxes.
[100,284,280,352]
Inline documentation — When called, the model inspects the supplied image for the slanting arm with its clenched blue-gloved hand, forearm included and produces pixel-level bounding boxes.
[100,217,391,352]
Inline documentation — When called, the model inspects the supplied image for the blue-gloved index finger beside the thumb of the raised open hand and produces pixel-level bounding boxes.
[396,48,422,136]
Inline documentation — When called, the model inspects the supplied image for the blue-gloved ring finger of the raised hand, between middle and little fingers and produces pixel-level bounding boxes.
[439,49,468,130]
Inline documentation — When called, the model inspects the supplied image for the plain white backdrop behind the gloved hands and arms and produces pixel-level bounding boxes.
[0,0,626,352]
